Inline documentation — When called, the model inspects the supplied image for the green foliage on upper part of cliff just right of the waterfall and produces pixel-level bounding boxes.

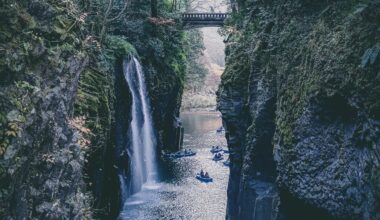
[125,6,187,88]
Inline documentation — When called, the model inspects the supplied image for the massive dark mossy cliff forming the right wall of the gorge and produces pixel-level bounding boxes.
[218,1,380,219]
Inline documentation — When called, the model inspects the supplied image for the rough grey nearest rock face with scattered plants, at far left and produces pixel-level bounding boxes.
[0,1,91,219]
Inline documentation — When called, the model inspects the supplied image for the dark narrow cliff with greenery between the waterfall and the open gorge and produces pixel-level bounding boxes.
[123,11,186,152]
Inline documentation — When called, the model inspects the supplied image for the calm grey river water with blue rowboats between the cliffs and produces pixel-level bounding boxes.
[120,113,229,220]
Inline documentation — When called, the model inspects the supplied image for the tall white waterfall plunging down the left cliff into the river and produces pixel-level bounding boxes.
[123,57,157,194]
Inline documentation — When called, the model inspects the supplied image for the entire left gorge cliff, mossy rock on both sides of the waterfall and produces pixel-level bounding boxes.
[0,0,184,219]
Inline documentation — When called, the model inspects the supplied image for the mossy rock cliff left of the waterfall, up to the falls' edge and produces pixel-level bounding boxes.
[0,0,140,219]
